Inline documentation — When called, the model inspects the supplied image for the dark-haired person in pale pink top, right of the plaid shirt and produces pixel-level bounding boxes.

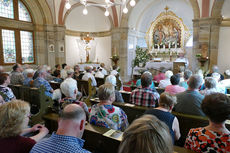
[165,74,185,95]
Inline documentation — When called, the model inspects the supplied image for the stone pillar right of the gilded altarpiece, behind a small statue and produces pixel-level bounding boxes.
[193,18,222,71]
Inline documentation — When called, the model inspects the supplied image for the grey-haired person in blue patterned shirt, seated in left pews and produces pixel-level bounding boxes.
[34,69,53,98]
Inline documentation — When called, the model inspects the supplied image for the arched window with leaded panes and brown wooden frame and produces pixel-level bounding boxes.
[0,0,35,65]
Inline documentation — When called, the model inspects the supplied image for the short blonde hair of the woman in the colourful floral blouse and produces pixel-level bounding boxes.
[98,83,115,100]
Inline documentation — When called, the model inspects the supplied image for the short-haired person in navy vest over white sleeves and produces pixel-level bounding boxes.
[145,92,180,142]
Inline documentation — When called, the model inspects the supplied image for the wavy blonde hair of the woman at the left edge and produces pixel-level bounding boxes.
[0,100,30,138]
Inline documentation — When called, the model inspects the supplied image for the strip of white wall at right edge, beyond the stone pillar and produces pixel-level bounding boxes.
[217,27,230,73]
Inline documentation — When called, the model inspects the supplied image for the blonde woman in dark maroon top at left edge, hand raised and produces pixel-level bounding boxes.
[0,100,49,153]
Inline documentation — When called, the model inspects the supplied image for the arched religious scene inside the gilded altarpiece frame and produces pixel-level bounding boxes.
[153,19,181,48]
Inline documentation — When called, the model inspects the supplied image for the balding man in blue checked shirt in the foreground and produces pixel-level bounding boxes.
[30,104,90,153]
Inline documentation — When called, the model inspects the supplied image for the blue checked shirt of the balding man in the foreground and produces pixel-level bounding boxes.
[30,132,90,153]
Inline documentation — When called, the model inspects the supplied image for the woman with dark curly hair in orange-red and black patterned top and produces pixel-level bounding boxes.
[185,93,230,153]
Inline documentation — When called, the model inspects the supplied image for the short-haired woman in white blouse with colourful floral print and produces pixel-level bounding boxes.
[89,83,128,131]
